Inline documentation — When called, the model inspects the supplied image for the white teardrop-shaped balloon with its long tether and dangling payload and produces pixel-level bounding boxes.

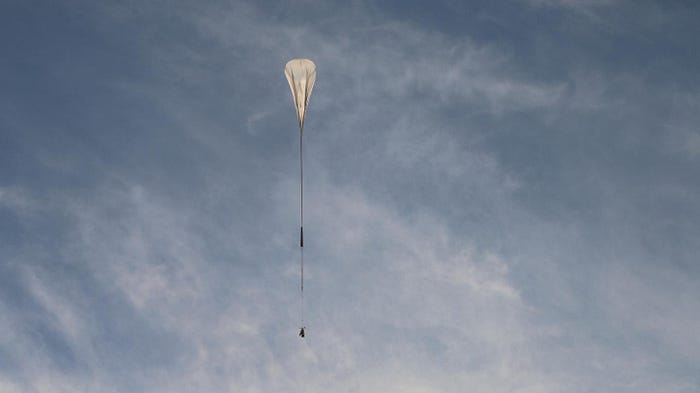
[284,59,316,338]
